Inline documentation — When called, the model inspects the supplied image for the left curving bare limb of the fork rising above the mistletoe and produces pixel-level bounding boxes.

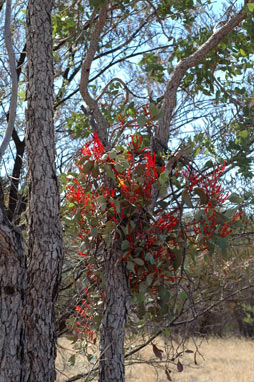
[79,3,109,147]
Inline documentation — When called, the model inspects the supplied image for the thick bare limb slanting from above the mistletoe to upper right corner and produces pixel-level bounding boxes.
[152,4,246,152]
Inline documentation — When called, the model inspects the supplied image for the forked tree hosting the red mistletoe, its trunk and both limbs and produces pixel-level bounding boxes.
[68,1,253,381]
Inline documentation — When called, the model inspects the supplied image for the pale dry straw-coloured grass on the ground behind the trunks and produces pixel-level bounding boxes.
[56,338,254,382]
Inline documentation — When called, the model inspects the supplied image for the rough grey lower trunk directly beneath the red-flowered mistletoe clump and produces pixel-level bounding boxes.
[99,242,130,382]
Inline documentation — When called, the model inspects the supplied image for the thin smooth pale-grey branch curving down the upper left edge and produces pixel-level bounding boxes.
[0,0,18,159]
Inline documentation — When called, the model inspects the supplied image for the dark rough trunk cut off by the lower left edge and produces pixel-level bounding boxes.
[0,201,26,382]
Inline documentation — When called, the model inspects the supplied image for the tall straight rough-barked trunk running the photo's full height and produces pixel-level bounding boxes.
[25,0,63,382]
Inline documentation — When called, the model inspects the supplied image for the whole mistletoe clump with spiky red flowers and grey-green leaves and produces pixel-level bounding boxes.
[66,118,241,338]
